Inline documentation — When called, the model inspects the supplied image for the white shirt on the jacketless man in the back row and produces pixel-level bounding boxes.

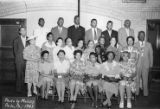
[33,26,49,48]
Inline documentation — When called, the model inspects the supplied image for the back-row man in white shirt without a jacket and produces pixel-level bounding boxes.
[33,18,49,48]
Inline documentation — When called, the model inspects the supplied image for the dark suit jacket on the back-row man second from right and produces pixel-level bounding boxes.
[102,30,118,47]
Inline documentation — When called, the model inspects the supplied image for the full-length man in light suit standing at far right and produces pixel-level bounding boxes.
[135,31,153,96]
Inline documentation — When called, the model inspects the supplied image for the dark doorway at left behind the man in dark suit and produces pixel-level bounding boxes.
[0,19,26,81]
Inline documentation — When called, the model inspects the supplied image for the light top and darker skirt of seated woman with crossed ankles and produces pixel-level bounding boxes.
[100,61,120,95]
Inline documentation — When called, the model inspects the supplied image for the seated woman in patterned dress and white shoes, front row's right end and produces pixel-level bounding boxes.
[119,51,136,108]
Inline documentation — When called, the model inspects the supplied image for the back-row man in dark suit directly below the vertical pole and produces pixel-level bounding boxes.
[68,15,85,47]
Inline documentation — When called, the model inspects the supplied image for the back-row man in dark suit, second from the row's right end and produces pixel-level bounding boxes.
[102,21,118,47]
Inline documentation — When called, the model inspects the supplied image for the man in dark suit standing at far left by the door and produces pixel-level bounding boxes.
[13,27,27,92]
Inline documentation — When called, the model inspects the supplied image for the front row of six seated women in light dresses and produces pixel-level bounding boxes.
[32,50,135,108]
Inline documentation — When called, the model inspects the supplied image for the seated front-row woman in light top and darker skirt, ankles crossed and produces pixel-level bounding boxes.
[100,51,120,108]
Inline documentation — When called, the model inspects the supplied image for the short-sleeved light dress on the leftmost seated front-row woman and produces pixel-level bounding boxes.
[38,62,54,87]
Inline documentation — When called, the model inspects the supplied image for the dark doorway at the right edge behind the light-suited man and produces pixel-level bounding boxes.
[147,19,160,80]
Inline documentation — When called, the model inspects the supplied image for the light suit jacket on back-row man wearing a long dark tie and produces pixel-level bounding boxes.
[85,28,102,43]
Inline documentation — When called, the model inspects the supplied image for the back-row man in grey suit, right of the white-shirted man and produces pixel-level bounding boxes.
[51,17,68,41]
